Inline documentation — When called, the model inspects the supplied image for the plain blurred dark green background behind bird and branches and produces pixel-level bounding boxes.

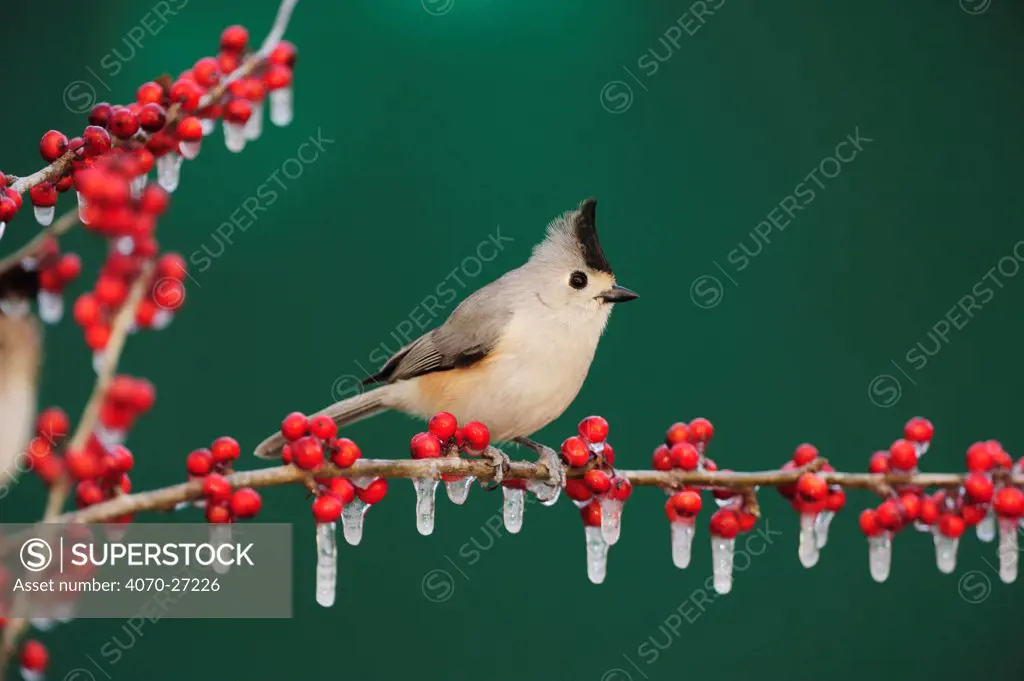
[0,0,1024,681]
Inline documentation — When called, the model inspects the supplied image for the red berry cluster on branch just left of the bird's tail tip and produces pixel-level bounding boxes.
[185,435,263,524]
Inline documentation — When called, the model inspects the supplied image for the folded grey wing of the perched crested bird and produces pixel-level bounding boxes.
[362,280,512,385]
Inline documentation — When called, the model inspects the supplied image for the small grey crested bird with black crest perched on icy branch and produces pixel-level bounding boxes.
[255,199,637,475]
